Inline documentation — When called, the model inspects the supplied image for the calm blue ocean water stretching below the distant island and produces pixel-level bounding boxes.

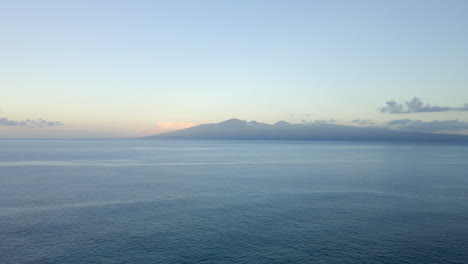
[0,140,468,264]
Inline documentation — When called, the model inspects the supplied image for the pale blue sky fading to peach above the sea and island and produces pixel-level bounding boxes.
[0,0,468,138]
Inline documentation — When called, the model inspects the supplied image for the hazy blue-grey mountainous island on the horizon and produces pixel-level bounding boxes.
[143,118,468,143]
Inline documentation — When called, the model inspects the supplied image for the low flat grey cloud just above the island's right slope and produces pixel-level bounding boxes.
[387,119,468,132]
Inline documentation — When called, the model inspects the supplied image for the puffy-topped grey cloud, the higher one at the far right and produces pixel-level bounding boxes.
[380,97,468,114]
